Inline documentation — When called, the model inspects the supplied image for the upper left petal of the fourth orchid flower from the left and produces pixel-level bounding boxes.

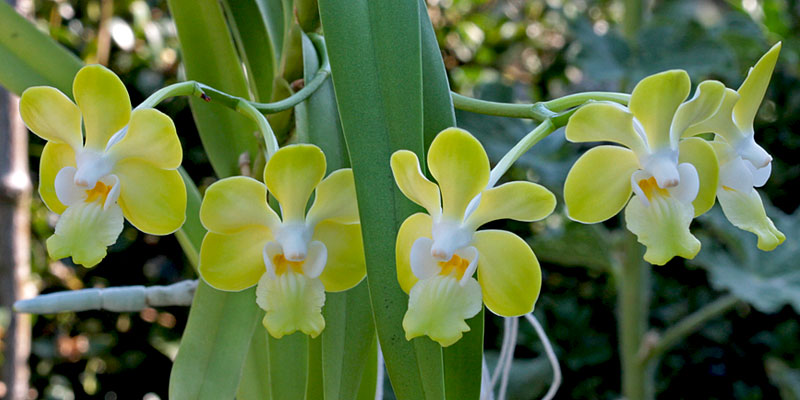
[565,102,646,154]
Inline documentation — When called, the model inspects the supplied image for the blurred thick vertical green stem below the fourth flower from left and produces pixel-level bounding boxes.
[617,233,653,400]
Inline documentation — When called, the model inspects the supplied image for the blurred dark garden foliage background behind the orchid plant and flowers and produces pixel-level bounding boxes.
[7,0,800,400]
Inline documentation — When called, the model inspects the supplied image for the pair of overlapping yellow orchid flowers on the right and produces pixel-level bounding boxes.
[564,44,784,265]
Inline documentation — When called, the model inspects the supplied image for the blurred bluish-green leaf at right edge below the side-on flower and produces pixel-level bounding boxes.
[691,204,800,313]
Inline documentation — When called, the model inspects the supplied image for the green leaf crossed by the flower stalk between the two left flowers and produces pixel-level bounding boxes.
[167,0,257,177]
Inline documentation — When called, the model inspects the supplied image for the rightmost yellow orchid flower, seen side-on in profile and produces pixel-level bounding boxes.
[684,43,786,251]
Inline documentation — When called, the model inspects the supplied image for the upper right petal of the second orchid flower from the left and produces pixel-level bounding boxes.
[306,168,358,227]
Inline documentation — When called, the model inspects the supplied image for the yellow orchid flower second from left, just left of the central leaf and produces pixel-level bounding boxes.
[199,144,366,338]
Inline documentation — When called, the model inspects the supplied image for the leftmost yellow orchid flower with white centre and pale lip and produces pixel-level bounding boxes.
[19,65,186,267]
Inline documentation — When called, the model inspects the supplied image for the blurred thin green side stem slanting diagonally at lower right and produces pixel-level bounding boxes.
[642,294,739,363]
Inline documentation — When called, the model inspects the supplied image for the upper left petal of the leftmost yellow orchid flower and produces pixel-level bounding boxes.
[19,86,83,150]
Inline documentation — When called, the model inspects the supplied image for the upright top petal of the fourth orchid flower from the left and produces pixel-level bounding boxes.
[628,70,691,151]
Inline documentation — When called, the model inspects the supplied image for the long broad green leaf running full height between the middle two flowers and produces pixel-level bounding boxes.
[319,0,444,400]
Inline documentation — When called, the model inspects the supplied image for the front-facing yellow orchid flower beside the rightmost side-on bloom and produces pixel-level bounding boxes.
[564,70,725,265]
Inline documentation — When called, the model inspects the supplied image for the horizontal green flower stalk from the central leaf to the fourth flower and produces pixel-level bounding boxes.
[451,92,631,122]
